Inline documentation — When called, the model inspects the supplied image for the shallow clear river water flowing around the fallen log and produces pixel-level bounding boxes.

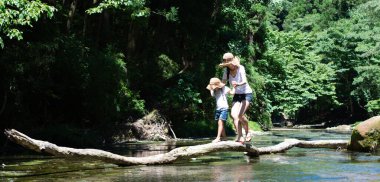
[0,130,380,182]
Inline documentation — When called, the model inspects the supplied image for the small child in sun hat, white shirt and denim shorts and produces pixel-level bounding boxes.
[206,78,235,143]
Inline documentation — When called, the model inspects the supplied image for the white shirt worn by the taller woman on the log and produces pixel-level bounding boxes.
[223,65,252,94]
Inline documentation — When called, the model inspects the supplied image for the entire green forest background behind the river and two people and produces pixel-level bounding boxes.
[0,0,380,145]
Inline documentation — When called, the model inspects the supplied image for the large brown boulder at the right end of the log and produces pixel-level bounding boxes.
[348,116,380,152]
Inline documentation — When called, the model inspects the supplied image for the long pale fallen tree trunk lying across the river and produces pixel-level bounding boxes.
[4,129,348,166]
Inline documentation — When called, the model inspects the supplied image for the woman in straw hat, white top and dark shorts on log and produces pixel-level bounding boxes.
[220,53,252,142]
